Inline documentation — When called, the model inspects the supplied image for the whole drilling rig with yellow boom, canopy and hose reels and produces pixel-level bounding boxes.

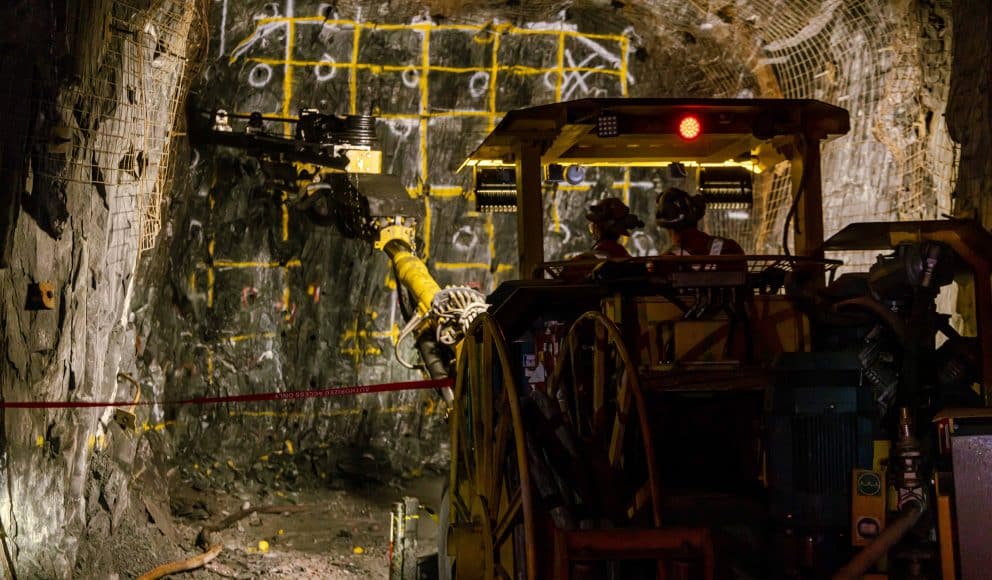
[192,99,992,580]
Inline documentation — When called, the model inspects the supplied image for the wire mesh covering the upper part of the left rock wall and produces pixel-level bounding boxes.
[18,0,195,263]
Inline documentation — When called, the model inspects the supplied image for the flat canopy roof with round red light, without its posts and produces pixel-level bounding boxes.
[466,98,850,165]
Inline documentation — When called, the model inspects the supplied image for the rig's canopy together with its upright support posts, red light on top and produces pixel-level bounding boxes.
[463,98,850,278]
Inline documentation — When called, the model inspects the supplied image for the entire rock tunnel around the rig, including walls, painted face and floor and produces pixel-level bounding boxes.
[0,0,992,578]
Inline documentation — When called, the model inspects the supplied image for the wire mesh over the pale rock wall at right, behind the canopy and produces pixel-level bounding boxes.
[695,0,958,269]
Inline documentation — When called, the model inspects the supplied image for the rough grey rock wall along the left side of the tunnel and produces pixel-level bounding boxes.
[0,1,192,578]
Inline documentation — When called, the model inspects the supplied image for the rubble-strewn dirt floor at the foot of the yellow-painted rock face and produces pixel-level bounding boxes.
[139,475,443,580]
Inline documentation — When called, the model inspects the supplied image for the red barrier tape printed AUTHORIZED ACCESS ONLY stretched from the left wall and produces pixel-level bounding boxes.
[0,379,454,409]
